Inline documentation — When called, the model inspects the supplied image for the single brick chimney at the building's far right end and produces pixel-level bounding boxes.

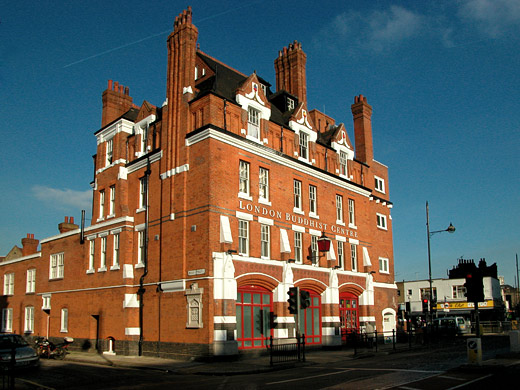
[350,95,374,165]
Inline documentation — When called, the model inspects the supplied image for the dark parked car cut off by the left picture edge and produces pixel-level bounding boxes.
[0,334,40,368]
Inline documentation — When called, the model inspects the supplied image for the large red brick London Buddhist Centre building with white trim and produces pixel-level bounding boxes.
[0,9,396,357]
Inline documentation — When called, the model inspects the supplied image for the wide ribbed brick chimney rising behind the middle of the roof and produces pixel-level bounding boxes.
[274,41,307,103]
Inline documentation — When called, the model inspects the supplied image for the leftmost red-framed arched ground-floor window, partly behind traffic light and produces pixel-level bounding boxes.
[237,286,273,349]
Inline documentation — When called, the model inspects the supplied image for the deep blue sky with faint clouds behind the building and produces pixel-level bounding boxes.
[0,0,520,284]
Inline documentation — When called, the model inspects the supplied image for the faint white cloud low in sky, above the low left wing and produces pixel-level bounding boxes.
[31,185,92,210]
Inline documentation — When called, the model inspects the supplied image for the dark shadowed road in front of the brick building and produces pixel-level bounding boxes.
[15,338,520,390]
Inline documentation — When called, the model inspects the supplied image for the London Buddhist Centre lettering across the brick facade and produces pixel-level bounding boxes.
[238,200,358,238]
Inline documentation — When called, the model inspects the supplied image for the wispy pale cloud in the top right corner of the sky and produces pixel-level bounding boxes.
[459,0,520,38]
